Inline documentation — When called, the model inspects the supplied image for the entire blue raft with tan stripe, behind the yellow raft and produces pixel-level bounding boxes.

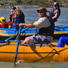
[0,25,68,40]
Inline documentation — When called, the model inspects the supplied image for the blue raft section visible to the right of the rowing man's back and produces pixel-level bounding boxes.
[54,25,68,39]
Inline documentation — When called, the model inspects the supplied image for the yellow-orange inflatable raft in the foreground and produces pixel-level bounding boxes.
[0,41,68,63]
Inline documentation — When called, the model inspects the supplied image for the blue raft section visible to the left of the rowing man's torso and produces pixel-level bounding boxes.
[0,28,36,40]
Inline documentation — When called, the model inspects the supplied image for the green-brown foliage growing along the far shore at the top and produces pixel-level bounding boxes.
[0,0,68,7]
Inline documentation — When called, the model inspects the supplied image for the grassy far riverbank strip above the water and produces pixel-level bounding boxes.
[0,0,68,7]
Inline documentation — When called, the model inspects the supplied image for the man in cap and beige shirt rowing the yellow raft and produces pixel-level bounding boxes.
[19,7,54,44]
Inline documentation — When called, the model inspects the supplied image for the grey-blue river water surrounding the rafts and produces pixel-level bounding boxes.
[0,5,68,68]
